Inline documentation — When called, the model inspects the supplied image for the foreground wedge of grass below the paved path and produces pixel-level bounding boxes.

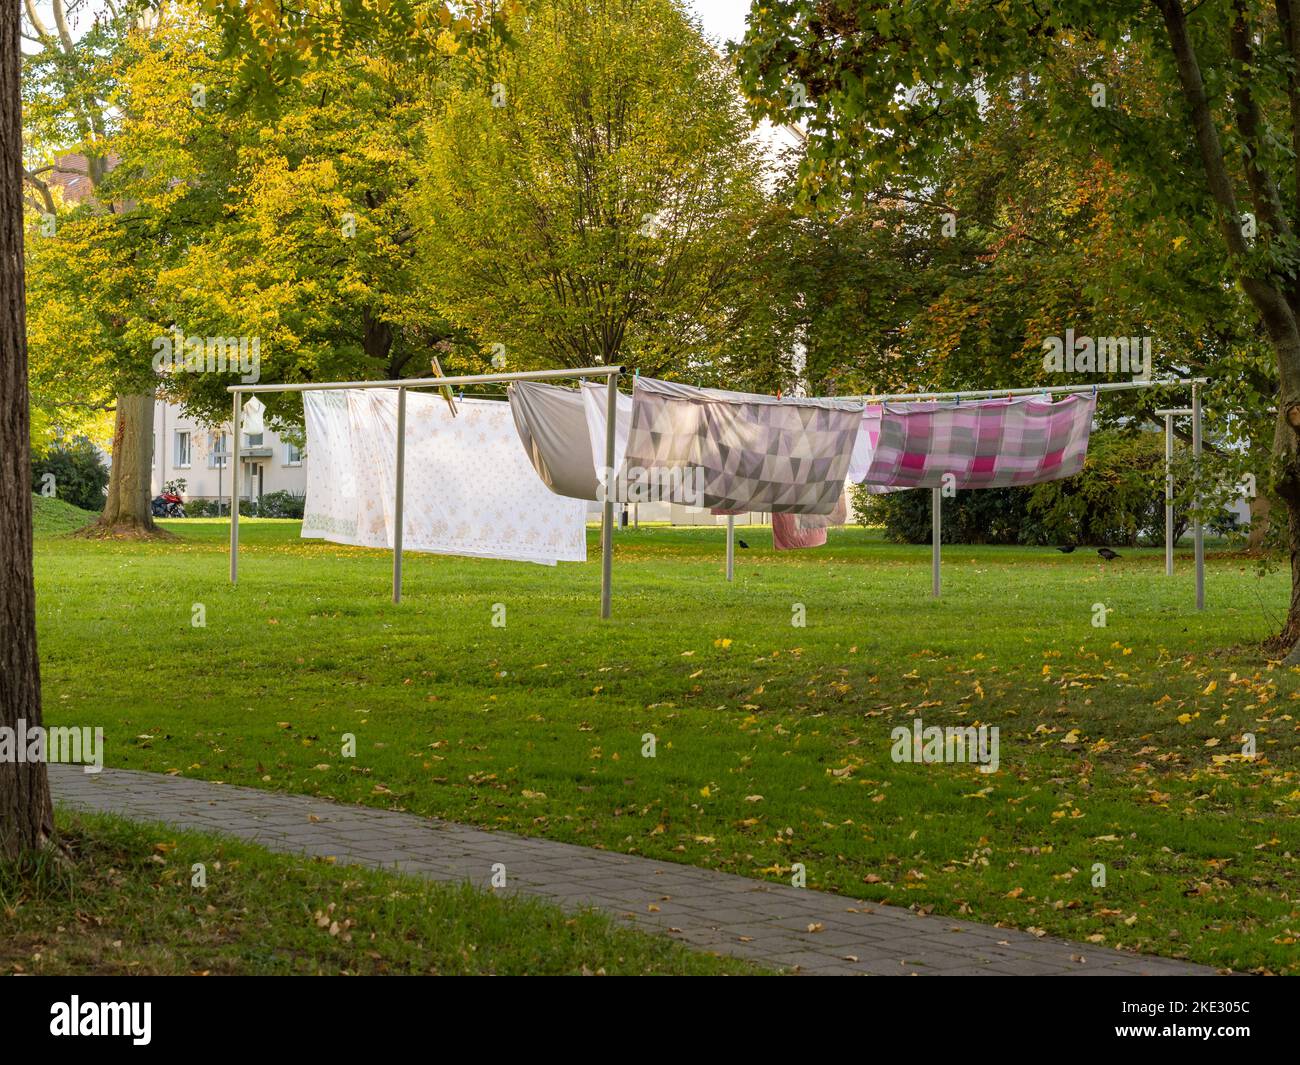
[0,814,759,975]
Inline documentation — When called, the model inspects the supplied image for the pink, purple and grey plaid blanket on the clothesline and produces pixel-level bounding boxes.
[850,395,1097,489]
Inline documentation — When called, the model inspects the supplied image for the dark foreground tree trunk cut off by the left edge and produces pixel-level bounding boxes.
[0,4,55,858]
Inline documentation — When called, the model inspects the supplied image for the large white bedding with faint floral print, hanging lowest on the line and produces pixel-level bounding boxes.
[303,389,586,566]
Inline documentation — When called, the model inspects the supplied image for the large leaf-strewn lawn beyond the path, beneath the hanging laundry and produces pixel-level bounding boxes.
[36,520,1300,971]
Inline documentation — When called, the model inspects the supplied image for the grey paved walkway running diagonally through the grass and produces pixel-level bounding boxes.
[49,765,1214,977]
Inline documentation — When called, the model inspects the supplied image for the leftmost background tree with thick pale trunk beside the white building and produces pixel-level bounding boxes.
[23,0,157,536]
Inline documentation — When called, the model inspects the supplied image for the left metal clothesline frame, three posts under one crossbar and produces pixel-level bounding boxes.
[226,365,623,618]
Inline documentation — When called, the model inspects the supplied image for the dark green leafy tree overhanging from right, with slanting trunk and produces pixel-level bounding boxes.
[738,0,1300,662]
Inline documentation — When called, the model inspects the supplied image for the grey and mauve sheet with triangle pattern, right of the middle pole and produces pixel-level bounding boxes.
[616,377,863,514]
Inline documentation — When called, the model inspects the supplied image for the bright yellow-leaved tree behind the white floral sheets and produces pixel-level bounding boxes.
[120,23,467,423]
